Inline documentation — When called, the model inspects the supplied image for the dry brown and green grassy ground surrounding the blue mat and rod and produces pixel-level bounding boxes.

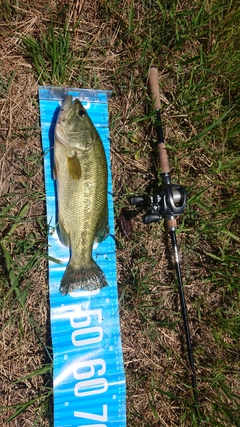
[0,0,240,427]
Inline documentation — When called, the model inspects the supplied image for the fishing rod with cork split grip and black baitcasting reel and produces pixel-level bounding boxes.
[130,67,198,408]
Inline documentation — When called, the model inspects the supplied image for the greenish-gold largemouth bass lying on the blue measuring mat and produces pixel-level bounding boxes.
[54,96,109,295]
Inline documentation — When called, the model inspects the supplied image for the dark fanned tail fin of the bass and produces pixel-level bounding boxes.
[60,260,108,295]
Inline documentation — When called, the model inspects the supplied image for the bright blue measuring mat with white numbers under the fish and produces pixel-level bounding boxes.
[39,86,126,427]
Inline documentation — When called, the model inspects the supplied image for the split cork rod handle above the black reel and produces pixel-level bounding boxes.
[148,67,170,173]
